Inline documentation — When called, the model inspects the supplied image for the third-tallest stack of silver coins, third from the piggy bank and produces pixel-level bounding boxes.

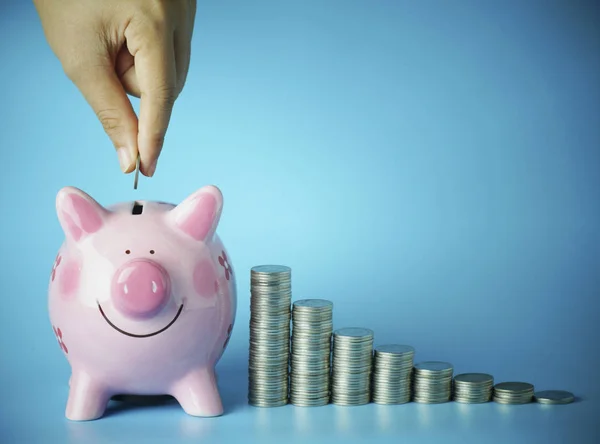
[331,328,375,406]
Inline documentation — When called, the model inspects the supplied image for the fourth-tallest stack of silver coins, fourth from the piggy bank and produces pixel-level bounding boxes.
[372,344,415,404]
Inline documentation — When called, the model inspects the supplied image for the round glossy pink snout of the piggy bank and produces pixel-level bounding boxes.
[111,259,170,317]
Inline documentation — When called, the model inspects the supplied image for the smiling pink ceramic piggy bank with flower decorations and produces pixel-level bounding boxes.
[49,186,237,420]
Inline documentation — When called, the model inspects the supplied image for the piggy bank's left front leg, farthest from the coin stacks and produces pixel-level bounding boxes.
[65,371,110,421]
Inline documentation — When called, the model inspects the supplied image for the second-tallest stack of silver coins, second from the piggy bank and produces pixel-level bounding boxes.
[290,299,333,407]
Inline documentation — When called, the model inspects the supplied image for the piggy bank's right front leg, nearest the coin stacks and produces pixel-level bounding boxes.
[171,368,223,417]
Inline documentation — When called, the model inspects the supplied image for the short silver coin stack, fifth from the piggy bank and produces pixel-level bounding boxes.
[413,361,454,404]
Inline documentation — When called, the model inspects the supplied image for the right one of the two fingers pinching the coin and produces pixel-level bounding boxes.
[126,27,178,177]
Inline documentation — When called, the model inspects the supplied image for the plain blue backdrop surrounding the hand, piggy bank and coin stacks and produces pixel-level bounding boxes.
[0,0,600,443]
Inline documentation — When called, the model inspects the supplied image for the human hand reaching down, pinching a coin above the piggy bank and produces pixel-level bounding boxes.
[34,0,196,176]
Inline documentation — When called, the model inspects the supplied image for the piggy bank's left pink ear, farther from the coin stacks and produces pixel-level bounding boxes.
[56,187,108,242]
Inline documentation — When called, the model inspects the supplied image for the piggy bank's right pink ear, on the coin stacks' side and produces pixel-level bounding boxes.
[169,185,223,241]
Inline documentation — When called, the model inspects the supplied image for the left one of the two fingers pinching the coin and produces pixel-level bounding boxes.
[68,56,138,173]
